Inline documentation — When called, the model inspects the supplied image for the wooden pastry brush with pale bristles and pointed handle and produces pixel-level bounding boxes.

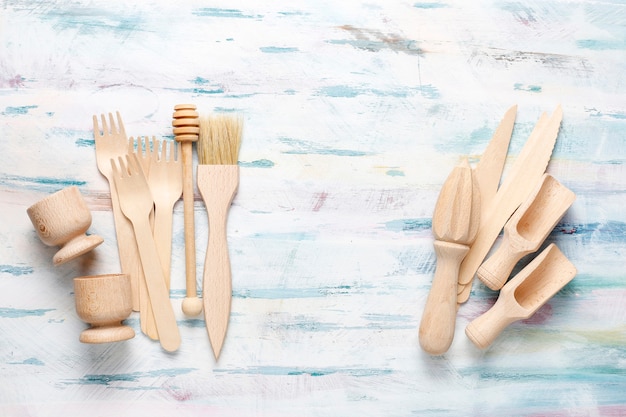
[197,115,243,360]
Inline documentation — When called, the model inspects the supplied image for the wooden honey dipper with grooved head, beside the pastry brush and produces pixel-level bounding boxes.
[172,104,202,316]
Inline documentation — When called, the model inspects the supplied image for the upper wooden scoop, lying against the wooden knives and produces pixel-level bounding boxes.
[477,174,576,291]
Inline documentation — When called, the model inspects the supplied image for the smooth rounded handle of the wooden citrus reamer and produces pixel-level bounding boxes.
[419,240,469,355]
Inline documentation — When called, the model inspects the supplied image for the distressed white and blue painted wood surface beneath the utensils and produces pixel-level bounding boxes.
[0,0,626,416]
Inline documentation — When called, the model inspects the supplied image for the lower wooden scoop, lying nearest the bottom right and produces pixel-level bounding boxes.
[465,243,576,349]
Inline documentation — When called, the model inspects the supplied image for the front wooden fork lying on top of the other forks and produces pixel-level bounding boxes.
[110,154,181,352]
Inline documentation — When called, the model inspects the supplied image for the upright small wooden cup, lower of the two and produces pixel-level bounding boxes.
[74,274,135,343]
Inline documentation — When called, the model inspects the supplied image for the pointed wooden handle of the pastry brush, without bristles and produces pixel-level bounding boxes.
[198,165,239,359]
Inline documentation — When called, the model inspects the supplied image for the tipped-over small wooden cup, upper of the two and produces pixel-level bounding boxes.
[26,186,103,265]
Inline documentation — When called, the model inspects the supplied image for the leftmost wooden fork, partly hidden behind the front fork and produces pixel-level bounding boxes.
[93,112,141,311]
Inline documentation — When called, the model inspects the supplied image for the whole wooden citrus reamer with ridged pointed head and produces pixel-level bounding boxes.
[419,159,480,355]
